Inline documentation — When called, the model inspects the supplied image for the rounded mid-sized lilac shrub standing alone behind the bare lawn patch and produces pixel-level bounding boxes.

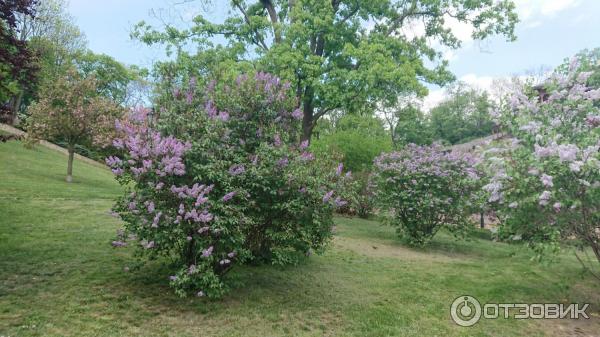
[373,144,479,245]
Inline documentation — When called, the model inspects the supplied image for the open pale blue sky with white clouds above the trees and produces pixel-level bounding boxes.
[69,0,600,105]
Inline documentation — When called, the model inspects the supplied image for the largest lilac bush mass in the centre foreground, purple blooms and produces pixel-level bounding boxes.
[107,73,346,297]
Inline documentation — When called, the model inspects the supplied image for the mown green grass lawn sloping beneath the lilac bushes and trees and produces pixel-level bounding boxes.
[0,142,600,337]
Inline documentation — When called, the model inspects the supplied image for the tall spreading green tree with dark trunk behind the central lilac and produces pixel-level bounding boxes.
[133,0,518,139]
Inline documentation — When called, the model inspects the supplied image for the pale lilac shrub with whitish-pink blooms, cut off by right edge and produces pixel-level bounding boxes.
[485,62,600,261]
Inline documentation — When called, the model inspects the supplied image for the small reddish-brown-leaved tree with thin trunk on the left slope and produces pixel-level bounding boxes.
[27,71,123,182]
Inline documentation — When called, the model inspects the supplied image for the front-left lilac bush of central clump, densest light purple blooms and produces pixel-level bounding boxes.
[106,110,247,297]
